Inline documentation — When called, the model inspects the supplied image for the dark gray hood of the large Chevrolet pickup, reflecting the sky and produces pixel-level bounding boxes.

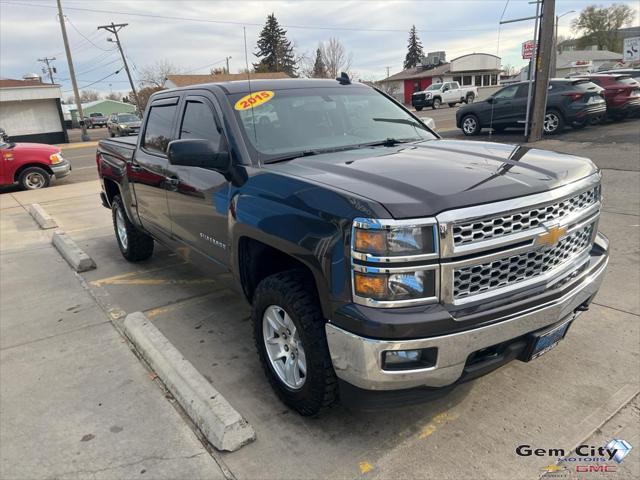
[266,140,598,218]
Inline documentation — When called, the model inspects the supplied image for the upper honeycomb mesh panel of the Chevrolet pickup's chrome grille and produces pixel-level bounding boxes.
[453,186,600,246]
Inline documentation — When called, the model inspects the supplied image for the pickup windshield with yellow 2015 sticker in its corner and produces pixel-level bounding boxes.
[230,86,435,163]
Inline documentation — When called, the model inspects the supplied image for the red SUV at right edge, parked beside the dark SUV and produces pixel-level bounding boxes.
[587,73,640,120]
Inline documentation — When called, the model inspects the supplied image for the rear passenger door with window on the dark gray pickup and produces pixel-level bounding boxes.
[128,97,179,235]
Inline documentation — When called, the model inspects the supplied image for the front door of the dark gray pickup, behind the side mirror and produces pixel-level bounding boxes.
[167,93,229,265]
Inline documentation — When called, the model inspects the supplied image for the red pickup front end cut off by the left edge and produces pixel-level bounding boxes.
[0,132,71,190]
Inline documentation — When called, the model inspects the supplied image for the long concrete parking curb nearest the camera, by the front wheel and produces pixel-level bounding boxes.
[124,312,256,451]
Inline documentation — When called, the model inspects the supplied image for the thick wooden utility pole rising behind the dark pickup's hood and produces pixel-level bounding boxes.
[527,0,556,142]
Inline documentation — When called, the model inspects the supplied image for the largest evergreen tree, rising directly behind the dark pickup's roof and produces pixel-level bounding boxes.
[253,13,296,77]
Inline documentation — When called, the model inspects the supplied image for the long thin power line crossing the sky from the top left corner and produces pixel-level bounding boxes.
[0,0,495,33]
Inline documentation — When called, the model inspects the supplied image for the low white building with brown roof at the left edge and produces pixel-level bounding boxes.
[0,79,69,144]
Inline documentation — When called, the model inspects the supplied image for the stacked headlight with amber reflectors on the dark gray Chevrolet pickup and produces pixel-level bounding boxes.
[351,218,439,307]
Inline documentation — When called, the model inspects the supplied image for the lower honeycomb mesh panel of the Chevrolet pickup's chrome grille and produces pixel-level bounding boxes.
[453,223,595,300]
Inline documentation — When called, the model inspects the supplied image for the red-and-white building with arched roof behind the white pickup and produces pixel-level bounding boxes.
[380,52,501,104]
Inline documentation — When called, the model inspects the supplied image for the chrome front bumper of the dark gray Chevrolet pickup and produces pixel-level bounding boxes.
[325,235,608,390]
